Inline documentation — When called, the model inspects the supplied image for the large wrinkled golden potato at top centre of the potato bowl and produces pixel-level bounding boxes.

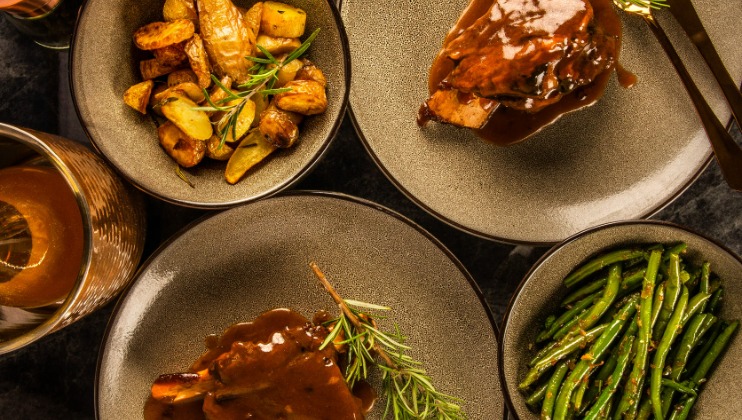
[196,0,255,83]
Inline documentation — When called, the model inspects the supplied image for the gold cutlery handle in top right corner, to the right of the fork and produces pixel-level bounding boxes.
[669,0,742,127]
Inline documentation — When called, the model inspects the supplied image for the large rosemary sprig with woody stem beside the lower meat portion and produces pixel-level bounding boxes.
[309,263,466,419]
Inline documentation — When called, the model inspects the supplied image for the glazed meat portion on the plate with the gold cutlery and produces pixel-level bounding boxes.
[423,0,619,128]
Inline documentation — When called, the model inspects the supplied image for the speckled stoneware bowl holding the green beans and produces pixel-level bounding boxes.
[500,221,742,419]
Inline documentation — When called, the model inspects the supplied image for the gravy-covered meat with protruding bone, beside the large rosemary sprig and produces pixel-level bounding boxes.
[145,309,364,420]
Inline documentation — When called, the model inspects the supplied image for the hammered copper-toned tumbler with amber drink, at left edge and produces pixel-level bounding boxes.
[0,123,146,354]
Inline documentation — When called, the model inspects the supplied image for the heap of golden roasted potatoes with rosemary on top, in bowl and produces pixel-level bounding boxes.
[124,0,327,184]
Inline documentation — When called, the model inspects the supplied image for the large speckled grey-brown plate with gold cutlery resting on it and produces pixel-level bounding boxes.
[340,0,742,244]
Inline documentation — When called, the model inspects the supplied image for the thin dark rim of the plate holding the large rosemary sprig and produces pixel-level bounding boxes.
[93,190,500,419]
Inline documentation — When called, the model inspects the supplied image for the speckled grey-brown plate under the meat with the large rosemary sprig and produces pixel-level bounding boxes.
[96,193,504,420]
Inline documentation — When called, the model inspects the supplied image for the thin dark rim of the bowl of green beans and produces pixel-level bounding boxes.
[497,219,742,418]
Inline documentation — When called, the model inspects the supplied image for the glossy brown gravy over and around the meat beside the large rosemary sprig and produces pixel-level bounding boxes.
[144,309,376,420]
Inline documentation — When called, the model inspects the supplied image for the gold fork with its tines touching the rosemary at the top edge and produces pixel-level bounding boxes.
[613,0,742,191]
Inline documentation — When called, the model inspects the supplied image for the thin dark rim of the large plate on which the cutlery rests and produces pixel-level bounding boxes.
[337,0,734,247]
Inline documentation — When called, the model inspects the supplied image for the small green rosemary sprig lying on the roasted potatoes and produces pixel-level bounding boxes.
[197,28,319,148]
